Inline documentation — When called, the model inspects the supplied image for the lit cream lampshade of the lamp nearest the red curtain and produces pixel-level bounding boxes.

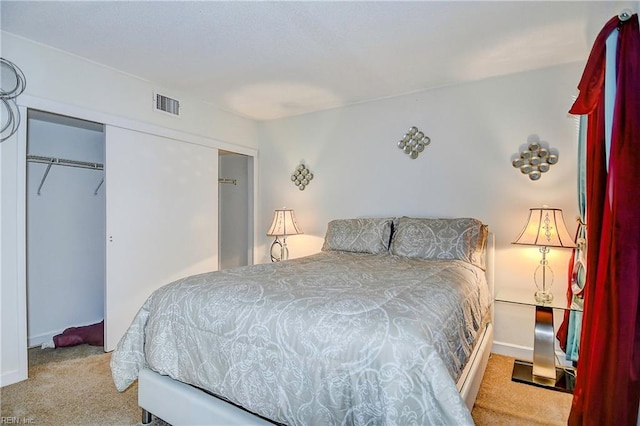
[513,207,576,248]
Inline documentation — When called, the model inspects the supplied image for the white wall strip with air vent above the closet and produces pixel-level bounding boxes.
[2,32,257,149]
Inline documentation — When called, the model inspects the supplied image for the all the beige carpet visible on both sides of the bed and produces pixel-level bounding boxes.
[0,345,571,426]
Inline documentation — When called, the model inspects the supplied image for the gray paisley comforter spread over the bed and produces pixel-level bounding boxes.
[111,251,489,425]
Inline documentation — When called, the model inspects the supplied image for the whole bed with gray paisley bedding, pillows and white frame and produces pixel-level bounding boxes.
[111,217,493,426]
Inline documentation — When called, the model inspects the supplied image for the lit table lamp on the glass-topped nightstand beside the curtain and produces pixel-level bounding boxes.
[512,206,576,303]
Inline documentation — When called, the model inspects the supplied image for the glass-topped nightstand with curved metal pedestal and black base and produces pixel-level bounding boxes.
[495,290,581,393]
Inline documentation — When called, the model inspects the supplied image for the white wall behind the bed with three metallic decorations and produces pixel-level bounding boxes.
[258,64,583,358]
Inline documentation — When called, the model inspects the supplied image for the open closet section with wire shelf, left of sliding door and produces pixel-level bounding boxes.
[26,110,105,346]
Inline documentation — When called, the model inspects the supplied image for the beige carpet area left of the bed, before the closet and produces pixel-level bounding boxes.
[0,345,141,426]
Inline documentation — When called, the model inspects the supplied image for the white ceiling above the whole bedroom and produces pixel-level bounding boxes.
[0,0,638,120]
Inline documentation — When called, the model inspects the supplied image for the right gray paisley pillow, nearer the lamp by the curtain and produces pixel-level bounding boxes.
[389,217,488,269]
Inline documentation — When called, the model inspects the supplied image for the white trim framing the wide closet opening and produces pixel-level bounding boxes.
[0,94,258,386]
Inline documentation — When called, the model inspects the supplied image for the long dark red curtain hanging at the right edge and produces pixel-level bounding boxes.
[569,14,640,425]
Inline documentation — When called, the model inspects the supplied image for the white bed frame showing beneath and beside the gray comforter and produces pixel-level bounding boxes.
[138,233,495,426]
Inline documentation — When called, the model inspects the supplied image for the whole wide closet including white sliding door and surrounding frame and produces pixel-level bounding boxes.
[0,97,257,385]
